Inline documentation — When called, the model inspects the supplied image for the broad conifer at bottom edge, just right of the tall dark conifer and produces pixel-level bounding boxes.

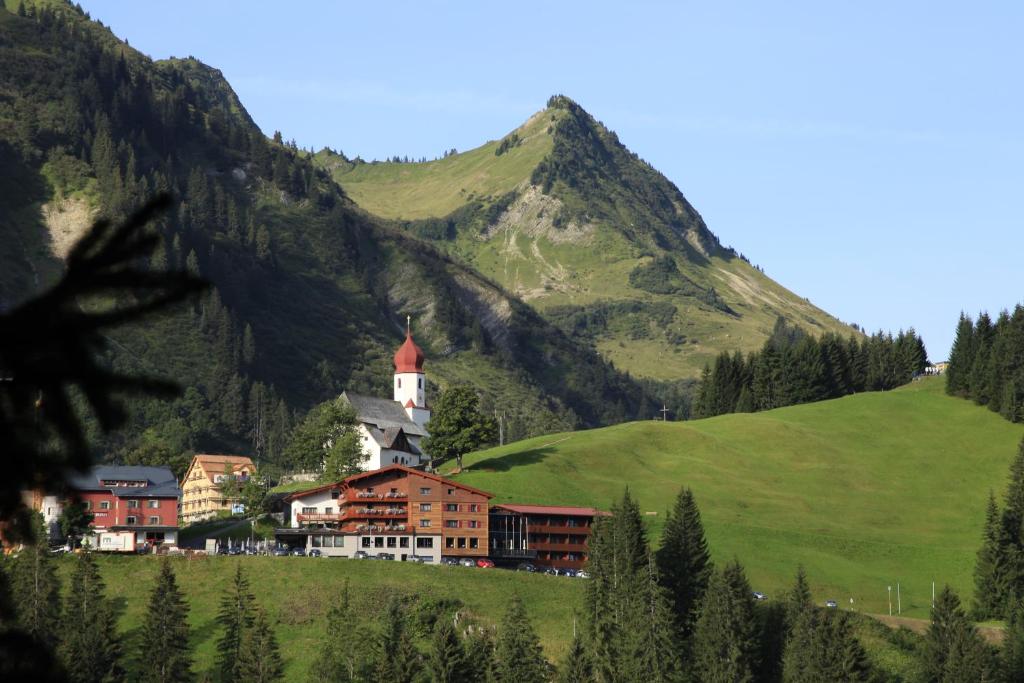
[693,560,759,683]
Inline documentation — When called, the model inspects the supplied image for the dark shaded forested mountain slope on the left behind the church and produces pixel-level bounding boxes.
[0,2,655,462]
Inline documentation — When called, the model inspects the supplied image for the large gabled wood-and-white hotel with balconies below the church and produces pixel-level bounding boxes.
[275,464,492,562]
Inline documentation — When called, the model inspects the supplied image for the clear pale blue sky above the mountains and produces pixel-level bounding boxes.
[82,0,1024,360]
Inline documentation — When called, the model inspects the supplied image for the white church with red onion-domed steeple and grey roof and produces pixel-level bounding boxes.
[341,322,430,470]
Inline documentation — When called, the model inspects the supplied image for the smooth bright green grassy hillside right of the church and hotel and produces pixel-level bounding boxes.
[448,379,1022,616]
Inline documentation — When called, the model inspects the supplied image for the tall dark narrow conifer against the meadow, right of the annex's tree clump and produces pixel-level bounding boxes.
[657,488,712,641]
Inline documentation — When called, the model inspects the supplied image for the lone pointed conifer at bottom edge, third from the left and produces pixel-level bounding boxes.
[138,558,193,683]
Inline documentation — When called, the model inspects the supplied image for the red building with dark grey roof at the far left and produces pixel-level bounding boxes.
[71,465,181,552]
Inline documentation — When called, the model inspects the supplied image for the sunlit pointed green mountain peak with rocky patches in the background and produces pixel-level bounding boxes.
[323,96,856,379]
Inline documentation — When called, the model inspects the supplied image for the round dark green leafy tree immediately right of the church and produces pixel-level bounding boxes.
[423,385,498,469]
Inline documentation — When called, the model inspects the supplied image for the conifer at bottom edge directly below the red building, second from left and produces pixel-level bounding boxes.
[60,551,124,683]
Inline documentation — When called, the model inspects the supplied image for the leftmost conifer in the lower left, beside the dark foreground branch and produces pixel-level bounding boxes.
[11,514,60,648]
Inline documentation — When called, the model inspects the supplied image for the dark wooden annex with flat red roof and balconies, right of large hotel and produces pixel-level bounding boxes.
[489,503,608,569]
